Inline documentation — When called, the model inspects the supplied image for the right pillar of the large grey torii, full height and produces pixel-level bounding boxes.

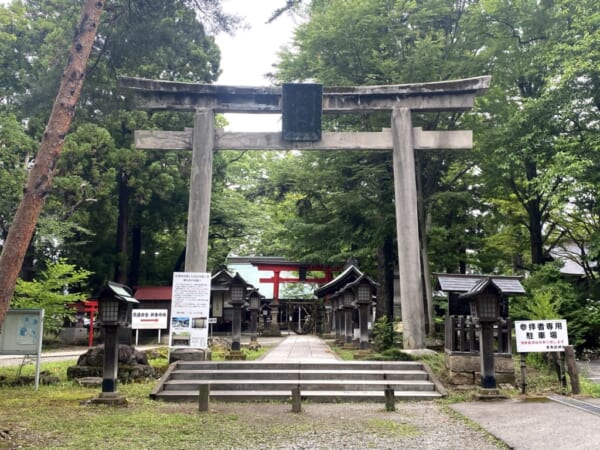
[392,108,425,349]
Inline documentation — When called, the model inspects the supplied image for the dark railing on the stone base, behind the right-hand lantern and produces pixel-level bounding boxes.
[444,316,511,354]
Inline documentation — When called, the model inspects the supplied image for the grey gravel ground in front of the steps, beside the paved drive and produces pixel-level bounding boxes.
[194,402,507,450]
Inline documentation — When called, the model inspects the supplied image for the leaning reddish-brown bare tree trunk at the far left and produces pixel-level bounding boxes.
[0,0,104,326]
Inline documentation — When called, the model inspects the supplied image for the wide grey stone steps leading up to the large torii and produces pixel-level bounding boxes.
[150,361,445,402]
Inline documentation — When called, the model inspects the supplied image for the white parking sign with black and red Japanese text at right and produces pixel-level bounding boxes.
[515,319,569,353]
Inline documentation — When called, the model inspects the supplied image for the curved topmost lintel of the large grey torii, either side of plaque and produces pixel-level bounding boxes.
[119,75,491,114]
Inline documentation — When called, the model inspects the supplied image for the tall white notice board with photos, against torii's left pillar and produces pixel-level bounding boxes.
[169,272,211,349]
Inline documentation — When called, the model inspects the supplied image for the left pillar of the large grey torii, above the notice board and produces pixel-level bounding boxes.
[185,109,215,272]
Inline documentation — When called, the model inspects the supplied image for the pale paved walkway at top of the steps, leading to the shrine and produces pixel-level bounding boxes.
[259,334,339,363]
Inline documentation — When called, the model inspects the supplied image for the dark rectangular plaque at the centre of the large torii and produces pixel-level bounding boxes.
[281,83,323,142]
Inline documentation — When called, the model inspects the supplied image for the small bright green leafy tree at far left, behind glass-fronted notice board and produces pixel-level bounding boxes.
[11,260,91,332]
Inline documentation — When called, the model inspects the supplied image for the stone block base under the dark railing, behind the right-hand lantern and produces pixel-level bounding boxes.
[444,350,515,386]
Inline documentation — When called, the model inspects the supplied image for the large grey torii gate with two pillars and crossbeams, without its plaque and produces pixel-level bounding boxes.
[119,76,491,349]
